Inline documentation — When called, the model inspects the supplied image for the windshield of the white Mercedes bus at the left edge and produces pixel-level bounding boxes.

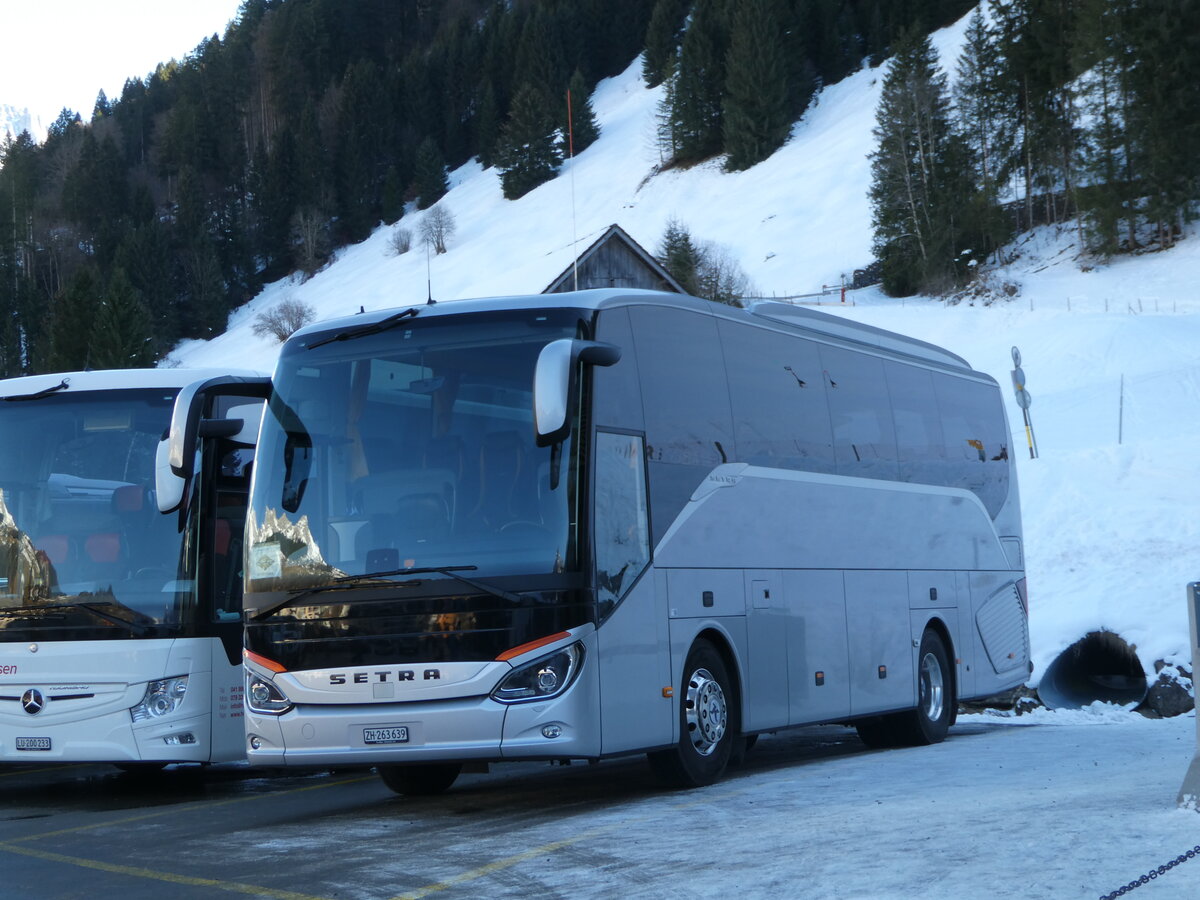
[0,388,196,641]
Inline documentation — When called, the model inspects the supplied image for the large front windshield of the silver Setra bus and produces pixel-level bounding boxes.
[246,310,580,606]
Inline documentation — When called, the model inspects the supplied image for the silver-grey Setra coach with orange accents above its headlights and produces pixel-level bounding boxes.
[238,290,1030,793]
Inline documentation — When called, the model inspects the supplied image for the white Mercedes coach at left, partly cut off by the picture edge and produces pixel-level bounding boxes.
[0,370,268,769]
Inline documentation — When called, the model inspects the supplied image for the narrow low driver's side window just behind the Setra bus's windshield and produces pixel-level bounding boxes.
[594,431,650,616]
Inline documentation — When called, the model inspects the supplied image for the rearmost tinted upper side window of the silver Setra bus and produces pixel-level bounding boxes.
[934,374,1009,516]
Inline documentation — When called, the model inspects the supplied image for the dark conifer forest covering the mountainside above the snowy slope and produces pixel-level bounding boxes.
[0,0,1200,377]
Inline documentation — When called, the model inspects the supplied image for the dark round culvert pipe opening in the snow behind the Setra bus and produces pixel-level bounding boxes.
[1038,631,1148,709]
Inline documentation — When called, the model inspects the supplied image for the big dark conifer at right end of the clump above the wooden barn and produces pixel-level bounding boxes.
[724,0,792,172]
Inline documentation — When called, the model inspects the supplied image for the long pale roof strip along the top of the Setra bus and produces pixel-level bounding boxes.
[289,288,972,371]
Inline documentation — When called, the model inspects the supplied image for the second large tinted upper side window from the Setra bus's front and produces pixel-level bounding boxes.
[720,322,834,472]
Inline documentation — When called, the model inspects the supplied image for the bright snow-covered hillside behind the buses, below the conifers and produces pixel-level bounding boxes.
[168,14,1200,700]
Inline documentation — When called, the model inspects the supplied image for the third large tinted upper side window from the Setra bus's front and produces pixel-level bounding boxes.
[821,347,899,479]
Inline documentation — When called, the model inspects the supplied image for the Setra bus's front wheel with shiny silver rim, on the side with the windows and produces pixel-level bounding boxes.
[648,640,742,787]
